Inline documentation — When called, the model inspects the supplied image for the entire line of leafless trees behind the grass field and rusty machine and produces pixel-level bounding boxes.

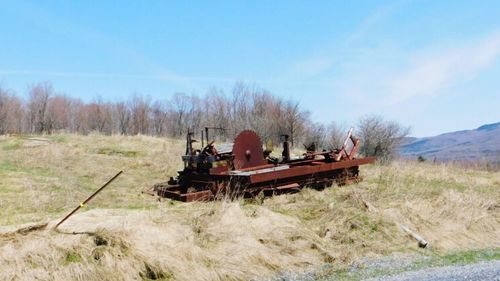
[0,82,408,160]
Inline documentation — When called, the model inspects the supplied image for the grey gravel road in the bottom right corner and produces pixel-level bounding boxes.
[365,260,500,281]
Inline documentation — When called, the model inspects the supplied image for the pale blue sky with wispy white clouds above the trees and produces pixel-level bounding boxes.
[0,0,500,136]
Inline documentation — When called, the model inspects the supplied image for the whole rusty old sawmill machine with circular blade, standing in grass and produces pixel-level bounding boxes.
[152,128,375,202]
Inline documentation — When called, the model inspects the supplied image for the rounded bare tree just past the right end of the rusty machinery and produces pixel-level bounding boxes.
[358,116,410,162]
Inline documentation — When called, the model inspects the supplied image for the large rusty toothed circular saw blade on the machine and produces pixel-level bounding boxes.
[233,130,266,169]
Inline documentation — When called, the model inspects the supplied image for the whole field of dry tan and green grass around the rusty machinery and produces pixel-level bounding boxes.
[0,134,500,280]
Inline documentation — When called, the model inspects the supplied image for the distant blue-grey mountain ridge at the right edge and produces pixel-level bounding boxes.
[400,122,500,164]
